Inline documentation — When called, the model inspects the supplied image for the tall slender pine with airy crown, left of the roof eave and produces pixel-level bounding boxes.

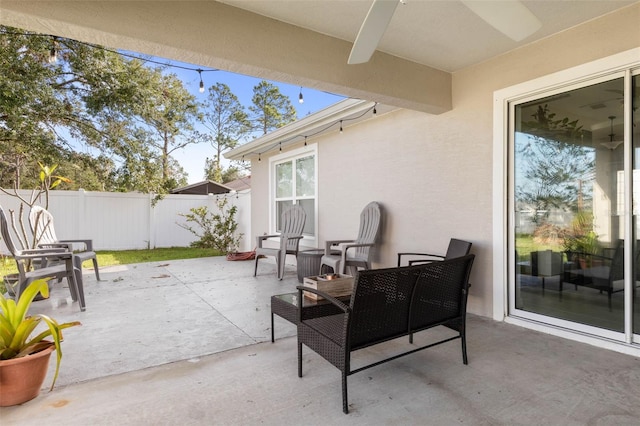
[203,83,251,182]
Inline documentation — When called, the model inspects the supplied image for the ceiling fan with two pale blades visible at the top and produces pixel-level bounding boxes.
[347,0,542,64]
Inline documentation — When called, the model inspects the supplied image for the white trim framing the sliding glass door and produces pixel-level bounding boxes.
[492,48,640,356]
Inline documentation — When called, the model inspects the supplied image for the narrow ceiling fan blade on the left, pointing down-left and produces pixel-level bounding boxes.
[347,0,399,64]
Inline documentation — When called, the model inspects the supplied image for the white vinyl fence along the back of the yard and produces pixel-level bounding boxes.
[0,190,251,253]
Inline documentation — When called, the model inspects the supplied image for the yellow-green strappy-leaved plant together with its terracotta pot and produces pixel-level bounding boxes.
[0,279,80,407]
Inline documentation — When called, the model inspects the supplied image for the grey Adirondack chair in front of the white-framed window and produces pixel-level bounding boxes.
[253,205,307,280]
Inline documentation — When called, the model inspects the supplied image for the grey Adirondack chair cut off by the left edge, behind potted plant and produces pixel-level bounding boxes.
[0,207,86,311]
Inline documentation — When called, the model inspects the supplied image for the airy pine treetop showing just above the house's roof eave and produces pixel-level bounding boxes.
[249,80,297,135]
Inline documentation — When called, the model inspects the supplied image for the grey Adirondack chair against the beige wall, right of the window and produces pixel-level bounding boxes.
[319,201,382,274]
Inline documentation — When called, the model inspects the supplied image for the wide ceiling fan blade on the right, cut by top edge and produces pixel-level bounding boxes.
[462,0,542,41]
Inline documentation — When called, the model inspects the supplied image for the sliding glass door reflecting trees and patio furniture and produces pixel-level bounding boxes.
[510,72,640,340]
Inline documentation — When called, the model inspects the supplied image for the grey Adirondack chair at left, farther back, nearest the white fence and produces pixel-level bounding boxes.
[29,206,100,281]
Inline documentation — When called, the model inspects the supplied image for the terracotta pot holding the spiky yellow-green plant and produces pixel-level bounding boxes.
[0,343,55,407]
